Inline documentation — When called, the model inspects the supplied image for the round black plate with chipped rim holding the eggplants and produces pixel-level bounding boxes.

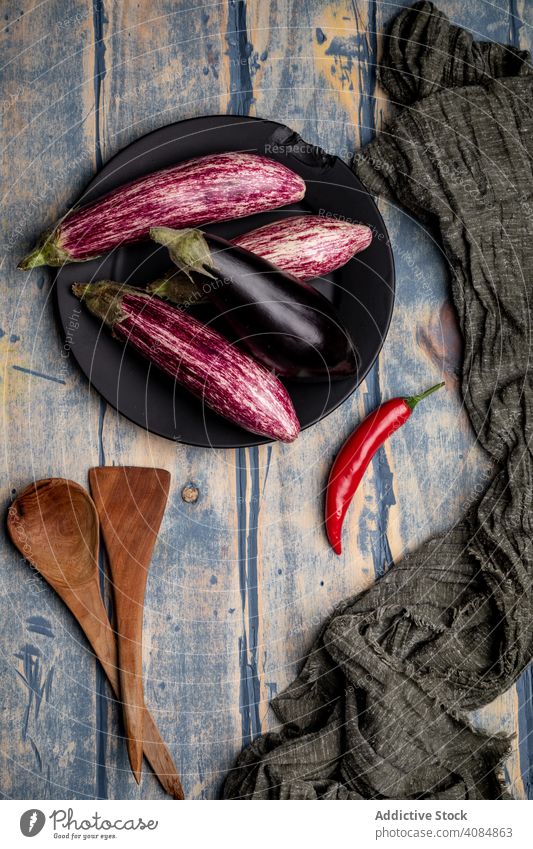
[56,115,394,448]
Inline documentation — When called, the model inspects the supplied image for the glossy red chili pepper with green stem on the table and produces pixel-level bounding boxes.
[326,383,444,554]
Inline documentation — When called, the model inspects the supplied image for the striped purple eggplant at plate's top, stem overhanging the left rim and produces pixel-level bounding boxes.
[19,152,305,269]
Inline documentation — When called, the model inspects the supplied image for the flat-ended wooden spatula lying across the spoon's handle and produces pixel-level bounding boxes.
[89,466,170,781]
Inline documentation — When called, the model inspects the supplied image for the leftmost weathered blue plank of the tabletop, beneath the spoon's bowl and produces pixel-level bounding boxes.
[0,2,105,799]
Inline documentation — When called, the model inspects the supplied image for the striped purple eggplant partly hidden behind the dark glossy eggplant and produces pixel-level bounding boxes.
[148,215,372,304]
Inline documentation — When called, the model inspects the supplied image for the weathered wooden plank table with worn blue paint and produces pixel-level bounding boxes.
[0,0,533,798]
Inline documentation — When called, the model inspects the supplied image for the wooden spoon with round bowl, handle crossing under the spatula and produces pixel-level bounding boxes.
[7,478,184,799]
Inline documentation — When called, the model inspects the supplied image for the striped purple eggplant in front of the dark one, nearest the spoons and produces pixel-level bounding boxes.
[72,280,300,442]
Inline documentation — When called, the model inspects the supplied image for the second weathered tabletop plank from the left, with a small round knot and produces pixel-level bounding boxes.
[89,0,241,798]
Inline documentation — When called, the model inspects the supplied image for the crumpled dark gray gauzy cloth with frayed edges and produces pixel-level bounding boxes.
[224,3,533,799]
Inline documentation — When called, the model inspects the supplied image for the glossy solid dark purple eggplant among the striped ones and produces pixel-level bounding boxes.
[150,227,357,379]
